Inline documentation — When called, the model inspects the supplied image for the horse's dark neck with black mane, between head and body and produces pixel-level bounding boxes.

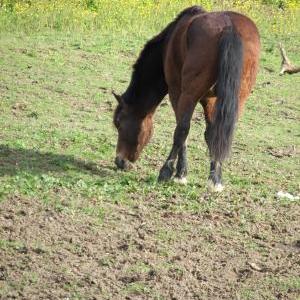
[122,6,204,116]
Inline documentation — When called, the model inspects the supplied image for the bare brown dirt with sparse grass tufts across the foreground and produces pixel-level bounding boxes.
[0,197,300,299]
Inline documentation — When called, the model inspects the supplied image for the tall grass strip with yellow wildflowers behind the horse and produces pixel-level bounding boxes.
[0,0,299,34]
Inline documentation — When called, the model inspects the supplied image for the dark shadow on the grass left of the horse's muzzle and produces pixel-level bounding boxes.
[0,145,114,177]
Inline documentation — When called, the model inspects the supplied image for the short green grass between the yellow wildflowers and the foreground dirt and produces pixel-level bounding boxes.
[0,25,299,211]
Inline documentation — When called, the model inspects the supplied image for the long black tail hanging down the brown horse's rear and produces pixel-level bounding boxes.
[206,26,243,162]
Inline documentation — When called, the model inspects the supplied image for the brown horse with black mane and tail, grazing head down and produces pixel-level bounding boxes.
[114,6,260,191]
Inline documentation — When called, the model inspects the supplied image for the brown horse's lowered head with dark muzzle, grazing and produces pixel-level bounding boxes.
[113,93,153,169]
